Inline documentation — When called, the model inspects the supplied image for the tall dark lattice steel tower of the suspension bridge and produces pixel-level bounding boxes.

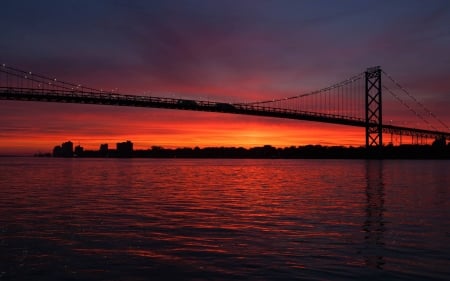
[365,66,383,148]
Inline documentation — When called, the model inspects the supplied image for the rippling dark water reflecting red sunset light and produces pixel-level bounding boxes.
[0,158,450,280]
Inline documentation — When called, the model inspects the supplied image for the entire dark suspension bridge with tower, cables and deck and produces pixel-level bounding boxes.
[0,64,450,148]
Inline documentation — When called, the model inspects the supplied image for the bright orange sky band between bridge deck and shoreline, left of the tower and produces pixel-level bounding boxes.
[0,101,364,153]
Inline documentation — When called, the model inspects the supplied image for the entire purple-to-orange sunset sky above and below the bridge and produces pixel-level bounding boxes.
[0,0,450,154]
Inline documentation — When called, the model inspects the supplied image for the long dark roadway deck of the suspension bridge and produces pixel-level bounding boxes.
[0,87,450,139]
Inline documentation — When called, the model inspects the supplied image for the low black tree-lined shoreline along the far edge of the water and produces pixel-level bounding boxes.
[34,145,450,159]
